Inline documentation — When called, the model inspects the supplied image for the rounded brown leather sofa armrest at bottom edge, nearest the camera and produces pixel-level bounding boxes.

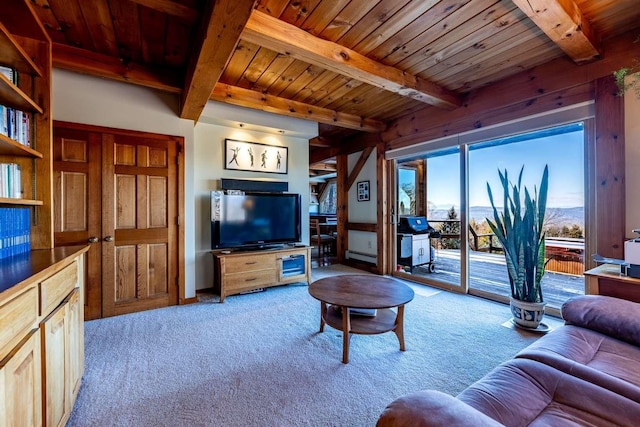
[376,390,502,427]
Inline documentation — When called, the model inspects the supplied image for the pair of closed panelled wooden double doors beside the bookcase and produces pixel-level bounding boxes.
[53,122,181,320]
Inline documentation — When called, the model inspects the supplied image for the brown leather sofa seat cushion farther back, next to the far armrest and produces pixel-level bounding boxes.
[516,325,640,402]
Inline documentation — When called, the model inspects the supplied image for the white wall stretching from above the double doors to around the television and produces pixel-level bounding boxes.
[52,69,317,298]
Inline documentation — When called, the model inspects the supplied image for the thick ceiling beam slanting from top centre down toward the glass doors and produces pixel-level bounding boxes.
[242,10,461,109]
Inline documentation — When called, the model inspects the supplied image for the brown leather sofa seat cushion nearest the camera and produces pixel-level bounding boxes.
[458,359,640,426]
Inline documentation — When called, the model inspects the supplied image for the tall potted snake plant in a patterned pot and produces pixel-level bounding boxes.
[487,166,549,328]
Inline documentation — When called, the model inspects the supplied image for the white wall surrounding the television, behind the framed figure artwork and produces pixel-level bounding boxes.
[193,118,317,289]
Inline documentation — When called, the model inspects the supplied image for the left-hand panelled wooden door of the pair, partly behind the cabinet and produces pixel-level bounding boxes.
[53,126,102,320]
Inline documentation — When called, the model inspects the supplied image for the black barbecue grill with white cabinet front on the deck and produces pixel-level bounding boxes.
[398,216,440,273]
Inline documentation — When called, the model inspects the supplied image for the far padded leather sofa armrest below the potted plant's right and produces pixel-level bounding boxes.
[562,295,640,346]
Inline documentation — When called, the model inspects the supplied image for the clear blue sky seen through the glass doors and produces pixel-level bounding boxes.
[427,125,584,208]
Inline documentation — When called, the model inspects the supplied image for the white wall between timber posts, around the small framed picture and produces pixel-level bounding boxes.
[347,150,378,256]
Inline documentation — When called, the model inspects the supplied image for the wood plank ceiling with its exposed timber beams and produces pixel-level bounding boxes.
[32,0,640,166]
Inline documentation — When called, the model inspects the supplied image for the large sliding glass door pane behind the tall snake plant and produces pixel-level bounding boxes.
[468,123,585,307]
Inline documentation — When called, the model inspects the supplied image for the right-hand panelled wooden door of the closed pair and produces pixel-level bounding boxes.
[102,134,178,317]
